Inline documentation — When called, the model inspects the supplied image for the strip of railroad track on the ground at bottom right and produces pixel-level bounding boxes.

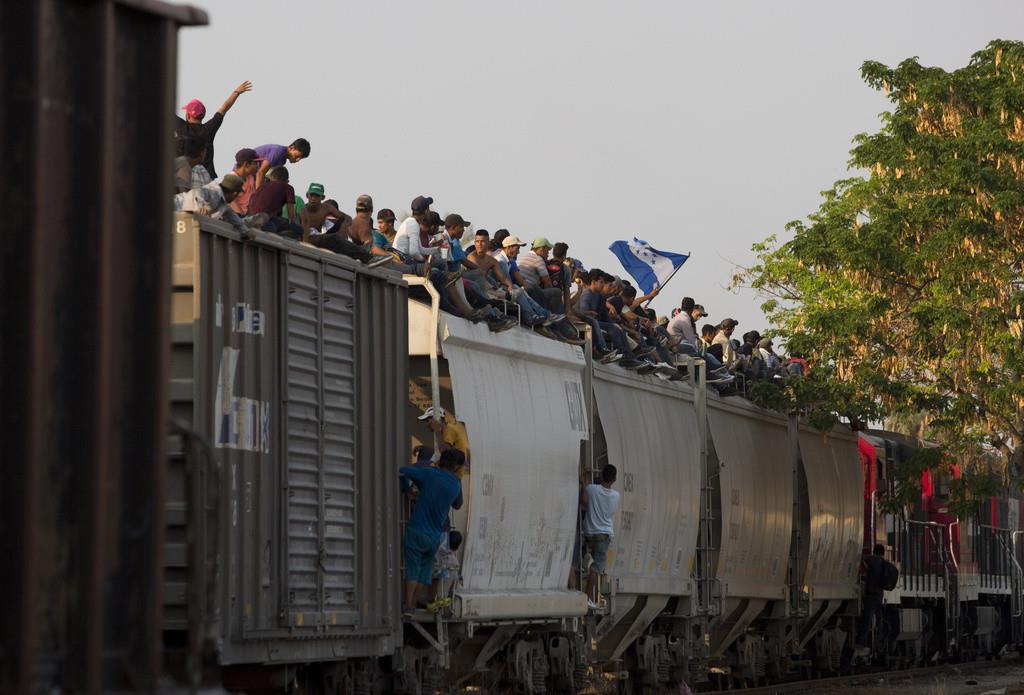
[699,656,1024,695]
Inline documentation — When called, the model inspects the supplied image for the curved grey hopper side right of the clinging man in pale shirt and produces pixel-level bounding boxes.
[594,366,701,596]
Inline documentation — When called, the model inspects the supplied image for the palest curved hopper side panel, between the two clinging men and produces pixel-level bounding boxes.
[442,317,587,601]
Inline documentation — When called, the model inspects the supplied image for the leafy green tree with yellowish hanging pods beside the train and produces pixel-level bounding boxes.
[736,41,1024,511]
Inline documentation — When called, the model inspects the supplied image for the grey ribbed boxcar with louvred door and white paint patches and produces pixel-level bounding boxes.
[164,213,408,665]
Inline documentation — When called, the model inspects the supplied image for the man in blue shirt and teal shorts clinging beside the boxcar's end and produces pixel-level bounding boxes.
[399,448,466,616]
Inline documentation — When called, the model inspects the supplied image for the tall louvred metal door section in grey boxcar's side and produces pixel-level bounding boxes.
[287,259,356,624]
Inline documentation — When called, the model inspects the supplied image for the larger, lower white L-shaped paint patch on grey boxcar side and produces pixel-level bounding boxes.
[213,345,270,453]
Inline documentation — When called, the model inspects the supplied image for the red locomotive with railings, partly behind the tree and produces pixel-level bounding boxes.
[861,431,1022,666]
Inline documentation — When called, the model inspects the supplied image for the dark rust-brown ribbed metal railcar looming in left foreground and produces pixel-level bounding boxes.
[0,0,205,693]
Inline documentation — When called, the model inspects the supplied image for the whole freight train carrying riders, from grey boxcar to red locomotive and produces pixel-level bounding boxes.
[163,214,1024,693]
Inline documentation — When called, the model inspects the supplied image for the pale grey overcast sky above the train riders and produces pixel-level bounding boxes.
[178,0,1024,333]
